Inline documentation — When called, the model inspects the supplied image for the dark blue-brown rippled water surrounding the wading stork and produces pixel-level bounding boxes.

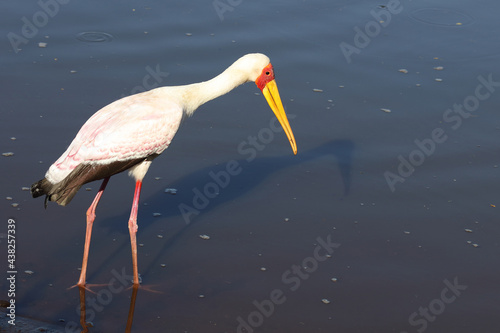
[0,0,500,333]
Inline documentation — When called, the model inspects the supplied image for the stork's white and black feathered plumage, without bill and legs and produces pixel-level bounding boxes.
[34,54,276,206]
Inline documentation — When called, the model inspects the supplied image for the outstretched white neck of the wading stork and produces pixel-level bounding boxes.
[159,62,249,116]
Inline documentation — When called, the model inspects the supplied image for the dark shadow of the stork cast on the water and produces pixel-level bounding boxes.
[93,140,355,282]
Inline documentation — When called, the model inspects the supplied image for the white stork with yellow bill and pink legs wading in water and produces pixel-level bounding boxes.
[31,53,297,286]
